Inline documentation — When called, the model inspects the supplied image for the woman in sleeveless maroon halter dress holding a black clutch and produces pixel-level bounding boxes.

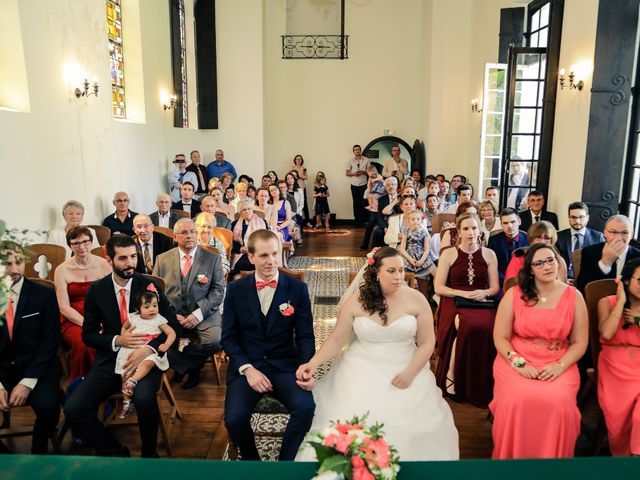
[434,213,499,408]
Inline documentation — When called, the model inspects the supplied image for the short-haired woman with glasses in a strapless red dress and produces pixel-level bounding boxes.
[53,227,111,381]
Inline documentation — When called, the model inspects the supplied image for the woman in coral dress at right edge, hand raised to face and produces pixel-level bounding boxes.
[598,260,640,455]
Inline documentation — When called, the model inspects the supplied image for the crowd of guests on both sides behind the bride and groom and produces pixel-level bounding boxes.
[0,150,640,458]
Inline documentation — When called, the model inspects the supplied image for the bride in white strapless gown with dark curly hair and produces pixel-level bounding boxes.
[296,247,459,461]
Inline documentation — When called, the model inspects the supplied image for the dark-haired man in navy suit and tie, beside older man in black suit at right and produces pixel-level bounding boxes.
[556,202,604,278]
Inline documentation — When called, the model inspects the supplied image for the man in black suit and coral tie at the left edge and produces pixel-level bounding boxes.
[0,245,61,454]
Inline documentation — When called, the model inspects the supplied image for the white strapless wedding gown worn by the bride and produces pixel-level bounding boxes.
[296,315,459,461]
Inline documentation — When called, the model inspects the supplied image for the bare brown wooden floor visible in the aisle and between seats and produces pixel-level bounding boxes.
[7,227,604,459]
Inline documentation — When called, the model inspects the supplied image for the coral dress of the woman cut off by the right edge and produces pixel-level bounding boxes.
[598,295,640,456]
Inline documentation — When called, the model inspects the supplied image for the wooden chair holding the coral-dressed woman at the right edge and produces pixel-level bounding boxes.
[578,278,618,455]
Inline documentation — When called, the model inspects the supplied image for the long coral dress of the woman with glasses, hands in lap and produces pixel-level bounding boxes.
[489,286,580,459]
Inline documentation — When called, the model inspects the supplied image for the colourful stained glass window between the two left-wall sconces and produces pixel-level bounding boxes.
[106,0,126,118]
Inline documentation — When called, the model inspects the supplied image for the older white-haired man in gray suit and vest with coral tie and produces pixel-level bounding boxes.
[153,218,225,389]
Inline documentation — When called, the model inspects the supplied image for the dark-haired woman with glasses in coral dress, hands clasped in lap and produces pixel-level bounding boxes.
[489,243,589,459]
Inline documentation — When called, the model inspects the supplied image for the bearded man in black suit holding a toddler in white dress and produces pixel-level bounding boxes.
[64,235,182,457]
